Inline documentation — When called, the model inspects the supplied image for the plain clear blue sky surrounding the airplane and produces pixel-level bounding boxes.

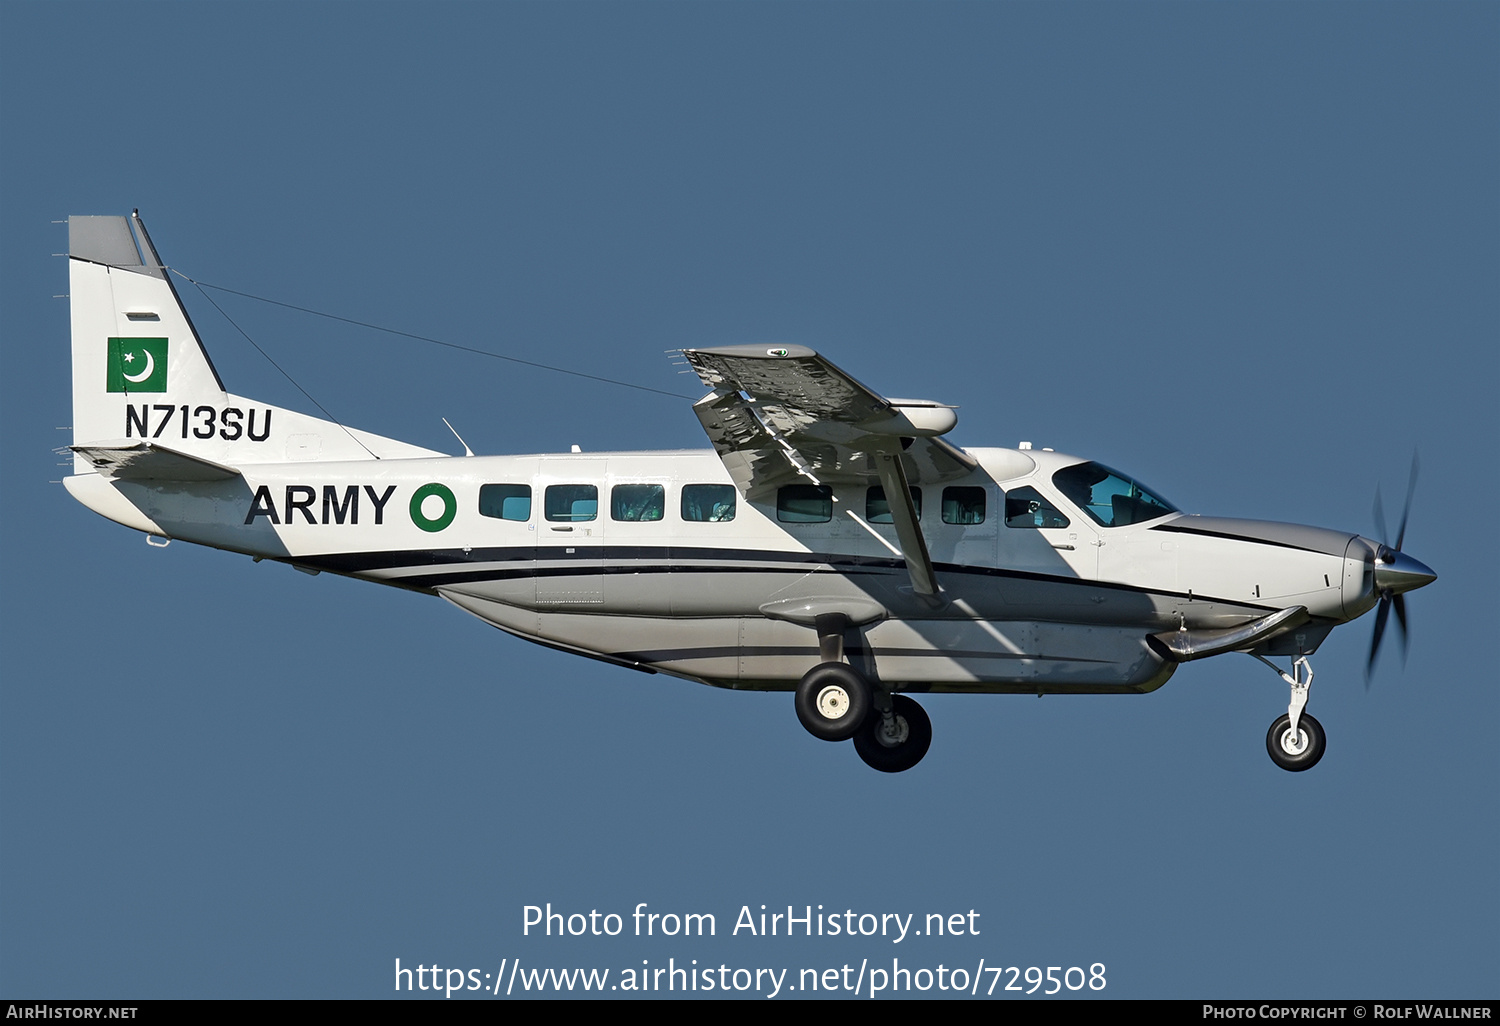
[0,3,1500,998]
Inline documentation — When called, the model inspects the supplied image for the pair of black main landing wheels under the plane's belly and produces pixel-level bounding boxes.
[797,662,933,773]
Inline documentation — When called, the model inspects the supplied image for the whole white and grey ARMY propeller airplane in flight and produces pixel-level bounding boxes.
[65,212,1436,773]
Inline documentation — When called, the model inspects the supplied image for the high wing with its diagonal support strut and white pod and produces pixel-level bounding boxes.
[683,345,977,596]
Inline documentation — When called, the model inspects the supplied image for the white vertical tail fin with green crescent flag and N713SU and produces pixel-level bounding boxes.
[68,213,441,474]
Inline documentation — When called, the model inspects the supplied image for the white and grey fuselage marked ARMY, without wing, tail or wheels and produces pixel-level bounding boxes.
[69,449,1370,692]
